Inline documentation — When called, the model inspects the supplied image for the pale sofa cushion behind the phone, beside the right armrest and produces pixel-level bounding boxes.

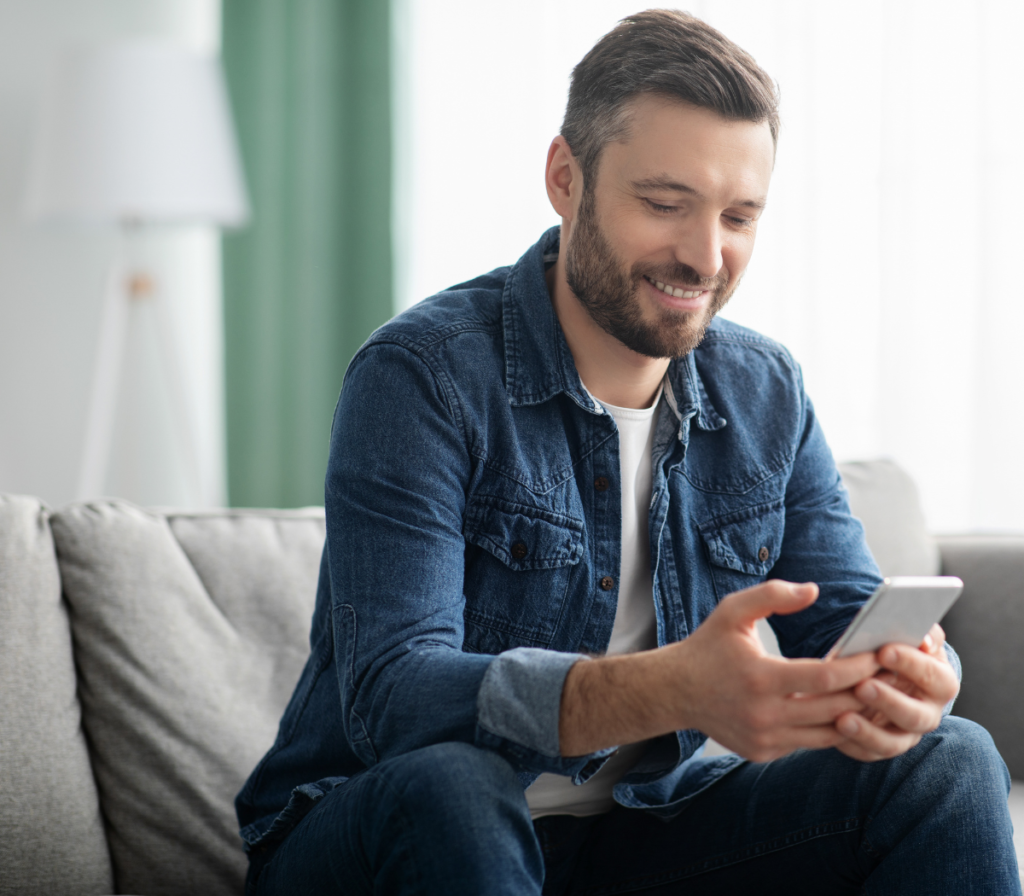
[839,460,941,575]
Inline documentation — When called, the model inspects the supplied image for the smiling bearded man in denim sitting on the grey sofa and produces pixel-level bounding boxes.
[238,11,1020,894]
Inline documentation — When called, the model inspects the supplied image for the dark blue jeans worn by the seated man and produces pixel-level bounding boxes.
[247,717,1021,896]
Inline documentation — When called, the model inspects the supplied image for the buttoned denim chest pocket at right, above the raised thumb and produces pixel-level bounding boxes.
[700,501,785,600]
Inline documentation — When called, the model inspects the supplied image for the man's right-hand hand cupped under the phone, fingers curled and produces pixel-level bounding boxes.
[836,625,959,762]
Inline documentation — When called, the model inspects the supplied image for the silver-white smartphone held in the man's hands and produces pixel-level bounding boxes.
[825,575,964,659]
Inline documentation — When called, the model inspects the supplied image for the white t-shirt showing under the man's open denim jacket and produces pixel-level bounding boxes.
[526,391,662,818]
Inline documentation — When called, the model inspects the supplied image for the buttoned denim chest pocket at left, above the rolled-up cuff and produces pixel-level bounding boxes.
[463,497,583,653]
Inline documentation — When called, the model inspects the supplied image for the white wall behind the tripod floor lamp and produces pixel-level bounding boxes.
[0,0,224,506]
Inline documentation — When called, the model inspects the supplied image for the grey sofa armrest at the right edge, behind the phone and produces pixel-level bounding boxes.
[938,536,1024,778]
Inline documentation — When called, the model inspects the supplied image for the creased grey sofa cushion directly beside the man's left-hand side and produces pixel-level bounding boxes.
[51,501,324,896]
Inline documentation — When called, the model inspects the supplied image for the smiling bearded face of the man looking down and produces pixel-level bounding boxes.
[565,96,774,357]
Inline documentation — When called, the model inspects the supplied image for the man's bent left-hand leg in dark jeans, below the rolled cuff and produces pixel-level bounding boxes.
[253,743,544,893]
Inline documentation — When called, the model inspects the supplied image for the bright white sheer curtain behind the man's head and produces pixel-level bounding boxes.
[395,0,1024,531]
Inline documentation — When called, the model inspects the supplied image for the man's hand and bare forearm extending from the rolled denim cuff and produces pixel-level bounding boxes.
[559,580,879,762]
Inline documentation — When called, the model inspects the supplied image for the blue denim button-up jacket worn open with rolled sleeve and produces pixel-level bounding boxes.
[237,228,881,849]
